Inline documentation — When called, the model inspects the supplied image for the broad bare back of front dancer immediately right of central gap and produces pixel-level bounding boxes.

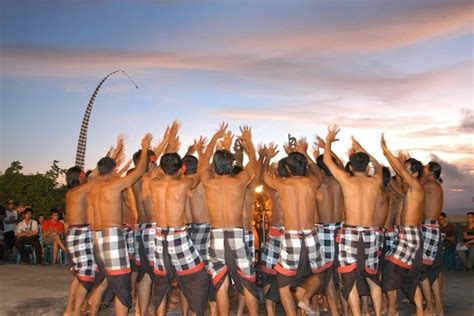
[276,176,317,230]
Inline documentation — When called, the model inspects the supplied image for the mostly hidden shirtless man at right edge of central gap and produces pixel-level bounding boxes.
[261,151,289,316]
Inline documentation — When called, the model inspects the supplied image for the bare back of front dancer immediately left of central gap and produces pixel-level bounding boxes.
[203,176,248,228]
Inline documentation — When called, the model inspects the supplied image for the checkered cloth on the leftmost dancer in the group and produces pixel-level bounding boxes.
[66,225,97,282]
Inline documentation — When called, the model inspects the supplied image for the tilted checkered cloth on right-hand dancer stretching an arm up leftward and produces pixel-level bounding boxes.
[385,225,422,269]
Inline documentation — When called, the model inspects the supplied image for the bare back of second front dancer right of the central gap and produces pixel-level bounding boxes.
[341,173,380,227]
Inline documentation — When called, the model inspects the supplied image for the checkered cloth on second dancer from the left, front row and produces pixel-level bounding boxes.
[94,227,131,275]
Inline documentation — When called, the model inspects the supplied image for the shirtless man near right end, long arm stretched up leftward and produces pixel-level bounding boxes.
[381,135,425,316]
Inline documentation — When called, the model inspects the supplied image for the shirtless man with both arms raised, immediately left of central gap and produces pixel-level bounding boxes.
[198,124,258,315]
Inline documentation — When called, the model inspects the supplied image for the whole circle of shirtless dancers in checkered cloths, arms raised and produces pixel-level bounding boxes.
[65,121,443,315]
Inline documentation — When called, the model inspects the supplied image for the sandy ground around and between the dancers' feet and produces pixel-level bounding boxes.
[0,264,474,316]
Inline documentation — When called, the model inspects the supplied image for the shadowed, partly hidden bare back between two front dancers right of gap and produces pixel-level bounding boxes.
[317,176,344,224]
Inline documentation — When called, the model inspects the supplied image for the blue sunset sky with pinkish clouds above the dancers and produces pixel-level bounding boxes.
[0,0,474,209]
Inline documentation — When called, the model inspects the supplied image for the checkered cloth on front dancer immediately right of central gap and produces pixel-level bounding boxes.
[275,228,322,276]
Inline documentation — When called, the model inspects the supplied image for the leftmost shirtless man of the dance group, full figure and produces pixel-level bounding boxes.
[65,167,97,316]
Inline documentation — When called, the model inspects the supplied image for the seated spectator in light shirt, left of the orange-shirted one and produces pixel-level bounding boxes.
[15,208,42,264]
